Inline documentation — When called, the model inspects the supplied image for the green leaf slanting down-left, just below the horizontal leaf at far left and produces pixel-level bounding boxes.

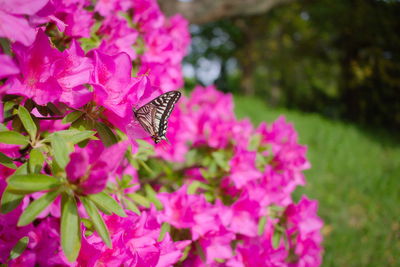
[17,190,61,227]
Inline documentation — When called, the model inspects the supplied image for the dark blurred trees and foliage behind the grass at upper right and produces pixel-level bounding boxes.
[187,0,400,128]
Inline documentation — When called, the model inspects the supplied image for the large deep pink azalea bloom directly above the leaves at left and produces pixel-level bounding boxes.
[5,31,92,107]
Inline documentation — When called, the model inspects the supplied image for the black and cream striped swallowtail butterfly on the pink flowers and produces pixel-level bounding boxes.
[133,91,182,144]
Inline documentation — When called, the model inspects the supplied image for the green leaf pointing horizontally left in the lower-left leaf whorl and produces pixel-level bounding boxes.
[7,173,61,194]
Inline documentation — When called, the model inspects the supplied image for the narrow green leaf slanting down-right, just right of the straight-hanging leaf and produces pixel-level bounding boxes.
[79,197,112,248]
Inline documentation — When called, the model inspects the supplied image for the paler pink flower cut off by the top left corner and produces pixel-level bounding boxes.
[0,0,48,46]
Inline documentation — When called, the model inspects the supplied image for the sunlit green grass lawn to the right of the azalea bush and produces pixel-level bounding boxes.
[235,97,400,266]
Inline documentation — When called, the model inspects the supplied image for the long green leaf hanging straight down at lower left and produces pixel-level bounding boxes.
[60,193,82,262]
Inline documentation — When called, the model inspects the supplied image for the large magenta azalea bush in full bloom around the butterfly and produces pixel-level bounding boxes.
[0,0,323,267]
